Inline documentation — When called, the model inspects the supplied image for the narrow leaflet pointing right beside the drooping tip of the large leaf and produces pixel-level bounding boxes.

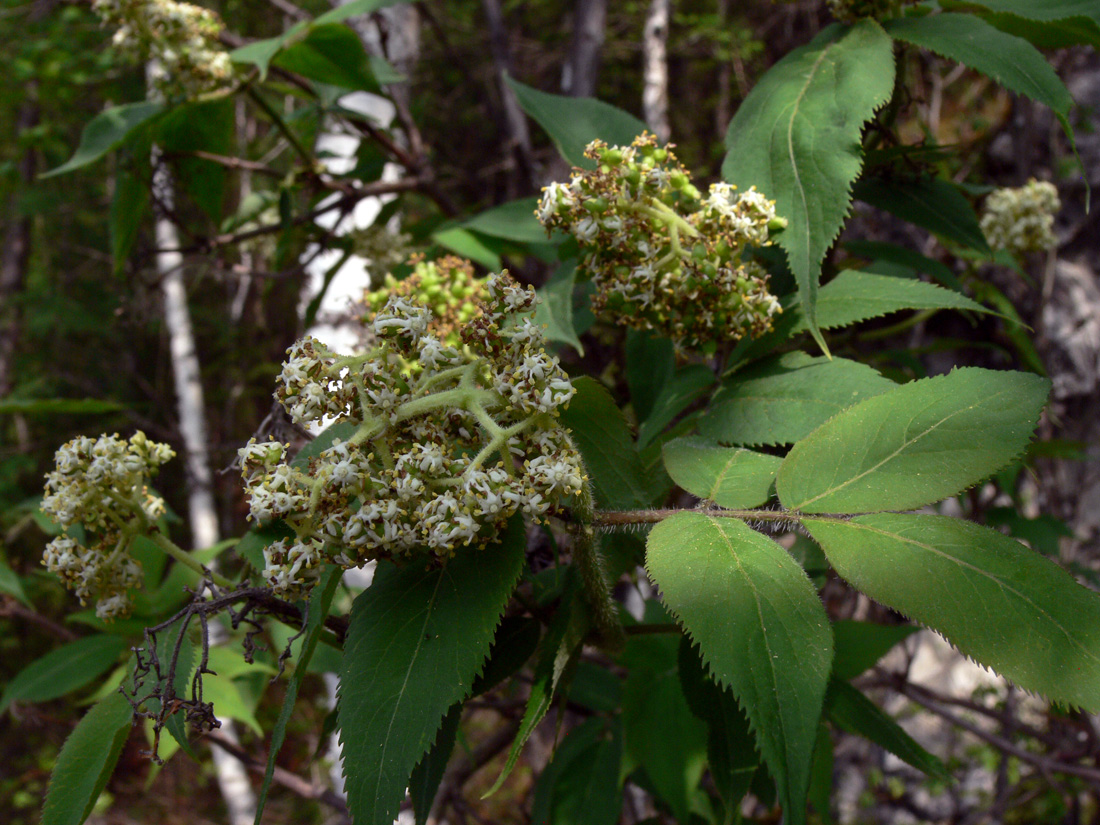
[793,270,989,331]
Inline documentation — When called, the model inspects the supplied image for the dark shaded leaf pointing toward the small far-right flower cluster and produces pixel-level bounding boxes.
[854,177,993,255]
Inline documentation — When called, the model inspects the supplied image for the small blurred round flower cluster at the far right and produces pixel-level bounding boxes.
[981,178,1062,254]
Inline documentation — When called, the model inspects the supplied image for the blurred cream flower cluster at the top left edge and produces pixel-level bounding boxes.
[92,0,233,98]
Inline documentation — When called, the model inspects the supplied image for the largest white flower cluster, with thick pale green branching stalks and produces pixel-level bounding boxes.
[240,273,585,596]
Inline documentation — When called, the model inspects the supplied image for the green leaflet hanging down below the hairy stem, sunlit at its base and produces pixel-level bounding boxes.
[646,513,833,823]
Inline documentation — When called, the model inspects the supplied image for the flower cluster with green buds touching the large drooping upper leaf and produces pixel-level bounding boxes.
[537,134,784,349]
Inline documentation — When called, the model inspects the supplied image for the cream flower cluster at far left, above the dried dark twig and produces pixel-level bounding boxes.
[42,432,175,619]
